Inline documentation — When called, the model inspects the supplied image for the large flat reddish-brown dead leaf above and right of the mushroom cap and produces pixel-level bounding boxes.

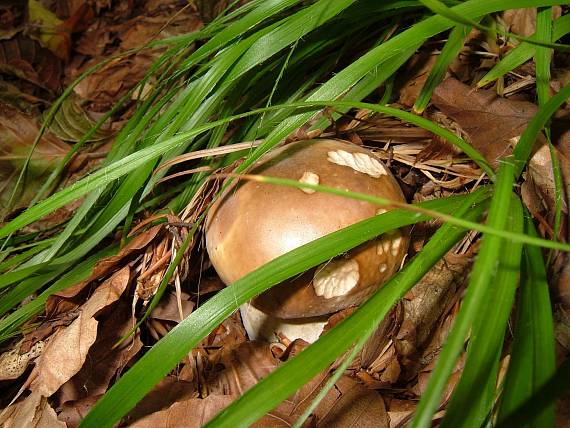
[432,78,537,166]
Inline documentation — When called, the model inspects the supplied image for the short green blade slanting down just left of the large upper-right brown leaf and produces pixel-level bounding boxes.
[414,25,471,114]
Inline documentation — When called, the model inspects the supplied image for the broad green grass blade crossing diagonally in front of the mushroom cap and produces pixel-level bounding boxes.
[82,189,486,427]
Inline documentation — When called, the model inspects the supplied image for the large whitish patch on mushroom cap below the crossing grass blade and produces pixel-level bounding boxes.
[313,259,360,299]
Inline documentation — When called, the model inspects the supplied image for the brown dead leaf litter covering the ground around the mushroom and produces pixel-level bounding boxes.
[0,0,570,428]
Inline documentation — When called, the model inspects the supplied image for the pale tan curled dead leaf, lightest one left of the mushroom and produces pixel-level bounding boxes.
[31,266,130,397]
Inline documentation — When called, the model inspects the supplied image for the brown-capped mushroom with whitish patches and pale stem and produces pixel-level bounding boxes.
[206,140,409,342]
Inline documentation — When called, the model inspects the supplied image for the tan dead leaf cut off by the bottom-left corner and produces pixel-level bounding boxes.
[0,392,66,428]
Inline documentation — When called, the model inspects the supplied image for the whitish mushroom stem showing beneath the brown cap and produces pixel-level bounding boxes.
[239,303,328,343]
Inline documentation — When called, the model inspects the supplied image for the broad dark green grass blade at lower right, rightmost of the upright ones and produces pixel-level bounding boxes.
[498,217,556,428]
